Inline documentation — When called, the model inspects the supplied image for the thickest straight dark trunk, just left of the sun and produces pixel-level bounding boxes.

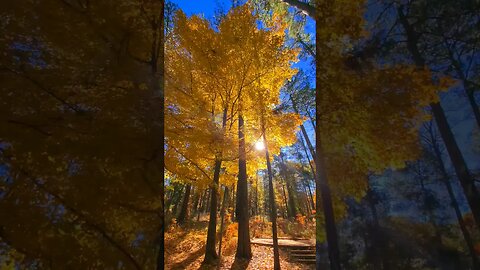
[235,114,252,259]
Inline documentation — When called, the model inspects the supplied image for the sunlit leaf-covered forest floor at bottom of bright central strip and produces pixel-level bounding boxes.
[165,218,315,270]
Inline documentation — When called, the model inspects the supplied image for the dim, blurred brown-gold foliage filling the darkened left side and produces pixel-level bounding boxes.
[0,0,164,269]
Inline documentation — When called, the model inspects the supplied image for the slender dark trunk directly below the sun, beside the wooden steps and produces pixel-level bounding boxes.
[263,130,280,270]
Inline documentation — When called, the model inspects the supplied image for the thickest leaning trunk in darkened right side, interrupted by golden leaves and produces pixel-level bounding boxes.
[397,7,480,228]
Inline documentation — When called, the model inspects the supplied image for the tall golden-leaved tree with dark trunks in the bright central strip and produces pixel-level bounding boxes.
[167,5,296,263]
